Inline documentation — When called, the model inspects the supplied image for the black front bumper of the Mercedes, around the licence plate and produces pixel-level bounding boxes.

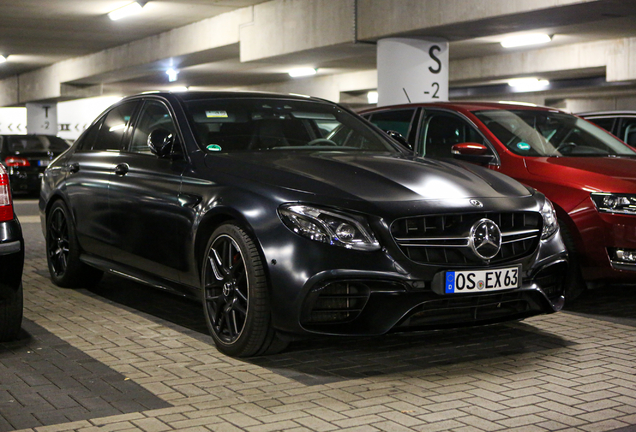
[264,223,568,336]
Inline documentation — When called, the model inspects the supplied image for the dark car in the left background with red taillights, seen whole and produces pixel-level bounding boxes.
[0,135,69,194]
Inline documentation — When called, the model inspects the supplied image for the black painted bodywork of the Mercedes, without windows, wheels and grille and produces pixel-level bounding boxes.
[40,93,566,348]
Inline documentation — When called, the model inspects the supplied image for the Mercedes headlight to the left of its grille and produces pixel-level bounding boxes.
[278,204,380,251]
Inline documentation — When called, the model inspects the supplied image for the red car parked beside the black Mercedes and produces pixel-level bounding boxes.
[361,102,636,295]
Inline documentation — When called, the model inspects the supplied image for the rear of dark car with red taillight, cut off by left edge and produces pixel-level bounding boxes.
[0,165,24,342]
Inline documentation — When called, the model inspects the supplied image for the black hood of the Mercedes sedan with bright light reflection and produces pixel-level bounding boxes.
[206,151,530,202]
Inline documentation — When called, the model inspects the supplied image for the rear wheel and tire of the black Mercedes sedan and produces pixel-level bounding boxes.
[46,201,104,288]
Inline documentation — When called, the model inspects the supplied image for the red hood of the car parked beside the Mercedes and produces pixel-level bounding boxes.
[526,157,636,193]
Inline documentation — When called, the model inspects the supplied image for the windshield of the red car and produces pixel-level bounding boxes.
[474,110,636,157]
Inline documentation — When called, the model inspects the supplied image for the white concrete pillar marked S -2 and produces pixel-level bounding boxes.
[378,38,448,106]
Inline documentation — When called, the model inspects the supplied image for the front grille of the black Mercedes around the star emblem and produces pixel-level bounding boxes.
[391,212,543,266]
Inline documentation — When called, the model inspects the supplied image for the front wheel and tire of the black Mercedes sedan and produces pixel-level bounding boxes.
[201,223,286,357]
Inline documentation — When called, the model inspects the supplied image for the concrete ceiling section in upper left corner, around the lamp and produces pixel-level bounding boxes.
[0,0,267,79]
